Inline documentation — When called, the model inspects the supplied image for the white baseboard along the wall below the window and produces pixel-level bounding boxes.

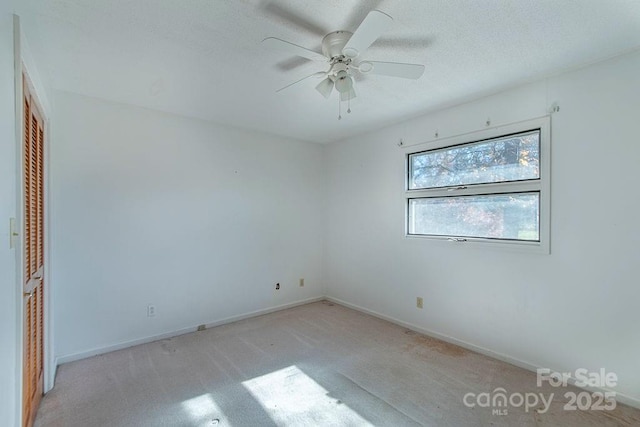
[326,296,640,409]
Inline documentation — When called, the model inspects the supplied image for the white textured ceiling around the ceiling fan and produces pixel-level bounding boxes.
[19,0,640,142]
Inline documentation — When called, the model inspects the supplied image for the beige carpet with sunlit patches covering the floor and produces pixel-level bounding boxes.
[36,301,640,427]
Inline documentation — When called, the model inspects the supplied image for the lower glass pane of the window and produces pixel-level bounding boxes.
[408,192,540,241]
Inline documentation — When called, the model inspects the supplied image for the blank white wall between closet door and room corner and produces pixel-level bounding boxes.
[50,92,326,361]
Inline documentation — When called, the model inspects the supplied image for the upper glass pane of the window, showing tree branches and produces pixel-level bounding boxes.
[409,130,540,190]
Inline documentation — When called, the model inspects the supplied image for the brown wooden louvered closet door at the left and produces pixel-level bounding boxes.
[22,76,45,426]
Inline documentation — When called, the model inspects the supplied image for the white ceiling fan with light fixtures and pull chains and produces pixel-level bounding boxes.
[262,10,424,119]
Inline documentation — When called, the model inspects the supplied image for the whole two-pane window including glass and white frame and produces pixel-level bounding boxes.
[405,119,550,251]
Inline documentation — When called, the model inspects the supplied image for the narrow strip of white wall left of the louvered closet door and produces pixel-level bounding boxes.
[0,6,19,426]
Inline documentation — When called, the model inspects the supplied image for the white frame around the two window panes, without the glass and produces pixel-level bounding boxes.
[404,116,551,254]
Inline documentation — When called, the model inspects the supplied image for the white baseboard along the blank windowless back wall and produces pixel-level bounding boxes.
[54,296,326,370]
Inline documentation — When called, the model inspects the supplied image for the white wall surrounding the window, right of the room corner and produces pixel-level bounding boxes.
[326,52,640,405]
